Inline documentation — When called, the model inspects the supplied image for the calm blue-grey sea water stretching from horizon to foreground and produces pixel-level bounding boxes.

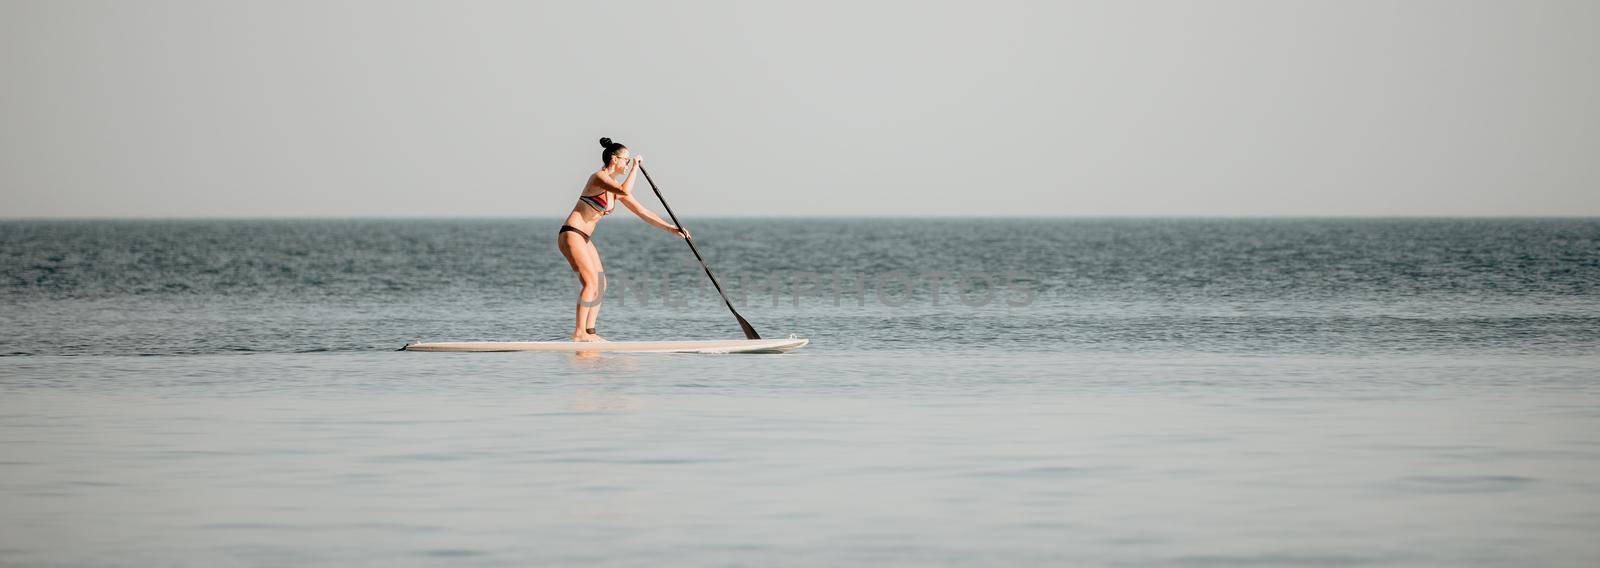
[0,219,1600,566]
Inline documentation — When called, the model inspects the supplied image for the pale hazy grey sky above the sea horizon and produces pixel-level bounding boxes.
[0,0,1600,218]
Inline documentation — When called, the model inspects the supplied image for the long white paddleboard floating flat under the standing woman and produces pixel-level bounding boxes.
[402,338,811,354]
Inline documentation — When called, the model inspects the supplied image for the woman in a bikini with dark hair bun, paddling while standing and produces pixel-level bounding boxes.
[555,138,690,341]
